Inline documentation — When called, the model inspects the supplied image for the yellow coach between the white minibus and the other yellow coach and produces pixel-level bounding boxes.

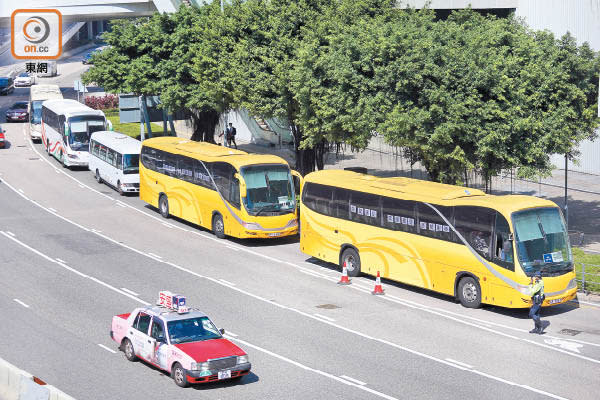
[140,136,300,238]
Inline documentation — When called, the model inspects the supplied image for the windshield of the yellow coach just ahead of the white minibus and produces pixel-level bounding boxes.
[241,165,296,215]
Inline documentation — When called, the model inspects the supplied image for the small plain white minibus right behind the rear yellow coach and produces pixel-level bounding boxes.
[89,131,142,196]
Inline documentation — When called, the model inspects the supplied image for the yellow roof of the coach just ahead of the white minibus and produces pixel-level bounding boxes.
[143,136,288,170]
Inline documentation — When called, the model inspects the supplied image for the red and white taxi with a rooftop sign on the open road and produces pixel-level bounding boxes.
[110,291,251,387]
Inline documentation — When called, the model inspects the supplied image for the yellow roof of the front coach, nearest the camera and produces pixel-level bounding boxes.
[304,169,556,215]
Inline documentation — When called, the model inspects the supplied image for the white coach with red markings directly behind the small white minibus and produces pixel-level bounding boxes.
[42,100,112,168]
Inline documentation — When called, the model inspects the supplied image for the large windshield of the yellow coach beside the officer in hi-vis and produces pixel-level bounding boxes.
[513,208,573,276]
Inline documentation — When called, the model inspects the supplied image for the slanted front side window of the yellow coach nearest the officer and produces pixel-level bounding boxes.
[454,206,496,260]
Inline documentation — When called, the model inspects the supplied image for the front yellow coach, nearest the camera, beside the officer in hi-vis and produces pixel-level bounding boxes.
[300,170,577,308]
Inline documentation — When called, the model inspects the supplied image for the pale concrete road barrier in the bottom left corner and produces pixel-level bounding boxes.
[0,358,75,400]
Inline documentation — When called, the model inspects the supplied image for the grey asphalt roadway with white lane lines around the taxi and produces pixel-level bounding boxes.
[0,57,600,399]
